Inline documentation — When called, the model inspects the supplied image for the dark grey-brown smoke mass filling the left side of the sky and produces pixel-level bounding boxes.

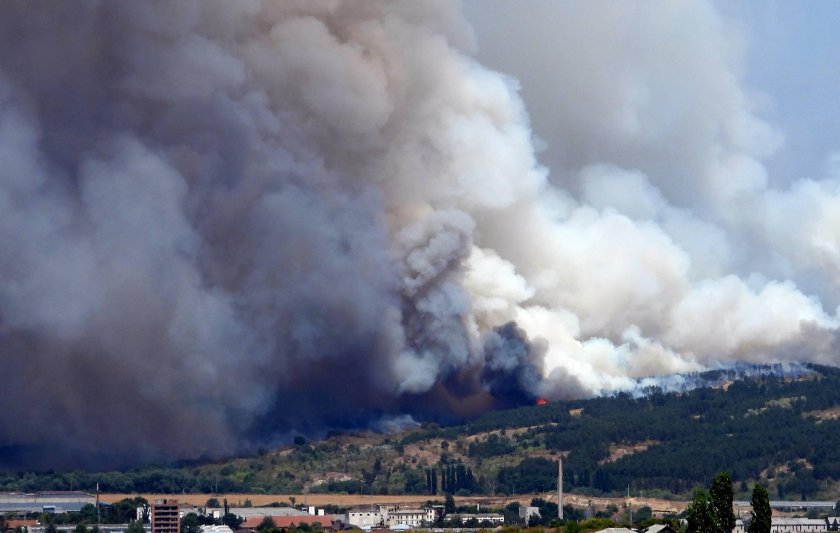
[0,0,552,466]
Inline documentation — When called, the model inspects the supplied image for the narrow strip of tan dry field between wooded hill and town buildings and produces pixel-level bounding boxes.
[100,493,686,512]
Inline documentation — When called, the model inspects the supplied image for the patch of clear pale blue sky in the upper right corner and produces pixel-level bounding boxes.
[717,1,840,185]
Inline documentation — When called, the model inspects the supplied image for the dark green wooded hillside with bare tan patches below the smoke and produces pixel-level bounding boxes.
[0,366,840,499]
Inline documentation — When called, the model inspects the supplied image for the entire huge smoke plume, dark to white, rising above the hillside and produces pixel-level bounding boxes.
[0,0,840,466]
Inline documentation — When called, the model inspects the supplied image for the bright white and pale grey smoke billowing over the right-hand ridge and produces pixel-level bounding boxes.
[467,2,837,391]
